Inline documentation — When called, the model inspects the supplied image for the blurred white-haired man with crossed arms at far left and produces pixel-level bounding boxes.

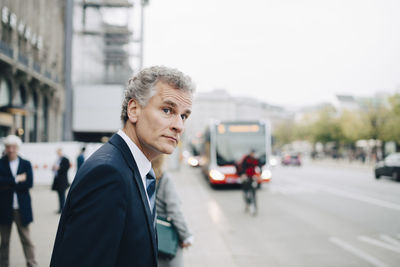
[0,135,37,267]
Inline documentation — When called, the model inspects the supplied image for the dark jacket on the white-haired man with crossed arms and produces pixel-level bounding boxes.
[0,156,33,225]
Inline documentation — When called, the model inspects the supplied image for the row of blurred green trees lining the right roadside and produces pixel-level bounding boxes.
[274,94,400,148]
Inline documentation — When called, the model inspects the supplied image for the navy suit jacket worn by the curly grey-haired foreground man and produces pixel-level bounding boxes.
[50,134,157,267]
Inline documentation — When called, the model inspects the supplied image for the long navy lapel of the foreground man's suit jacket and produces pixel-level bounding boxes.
[109,134,157,258]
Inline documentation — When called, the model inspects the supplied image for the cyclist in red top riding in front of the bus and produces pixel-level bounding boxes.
[239,149,259,215]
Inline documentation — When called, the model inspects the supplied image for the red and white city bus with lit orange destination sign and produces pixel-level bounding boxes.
[201,121,272,187]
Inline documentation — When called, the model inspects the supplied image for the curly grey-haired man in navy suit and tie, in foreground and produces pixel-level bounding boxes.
[50,66,194,267]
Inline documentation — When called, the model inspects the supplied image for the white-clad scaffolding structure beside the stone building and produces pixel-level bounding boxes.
[72,0,133,142]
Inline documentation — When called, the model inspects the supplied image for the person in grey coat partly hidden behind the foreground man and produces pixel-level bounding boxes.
[152,155,193,267]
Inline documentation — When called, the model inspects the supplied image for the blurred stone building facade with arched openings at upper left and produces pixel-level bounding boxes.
[0,0,65,142]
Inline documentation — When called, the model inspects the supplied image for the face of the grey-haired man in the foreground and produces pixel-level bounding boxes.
[128,82,192,160]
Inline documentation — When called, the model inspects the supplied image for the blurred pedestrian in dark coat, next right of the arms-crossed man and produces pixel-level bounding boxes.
[51,148,70,213]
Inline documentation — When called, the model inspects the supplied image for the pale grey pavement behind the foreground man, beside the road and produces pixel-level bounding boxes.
[10,166,236,267]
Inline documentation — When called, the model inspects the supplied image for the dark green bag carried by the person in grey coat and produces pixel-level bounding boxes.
[157,216,179,259]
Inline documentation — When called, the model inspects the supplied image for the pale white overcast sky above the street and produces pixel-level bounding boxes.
[144,0,400,109]
